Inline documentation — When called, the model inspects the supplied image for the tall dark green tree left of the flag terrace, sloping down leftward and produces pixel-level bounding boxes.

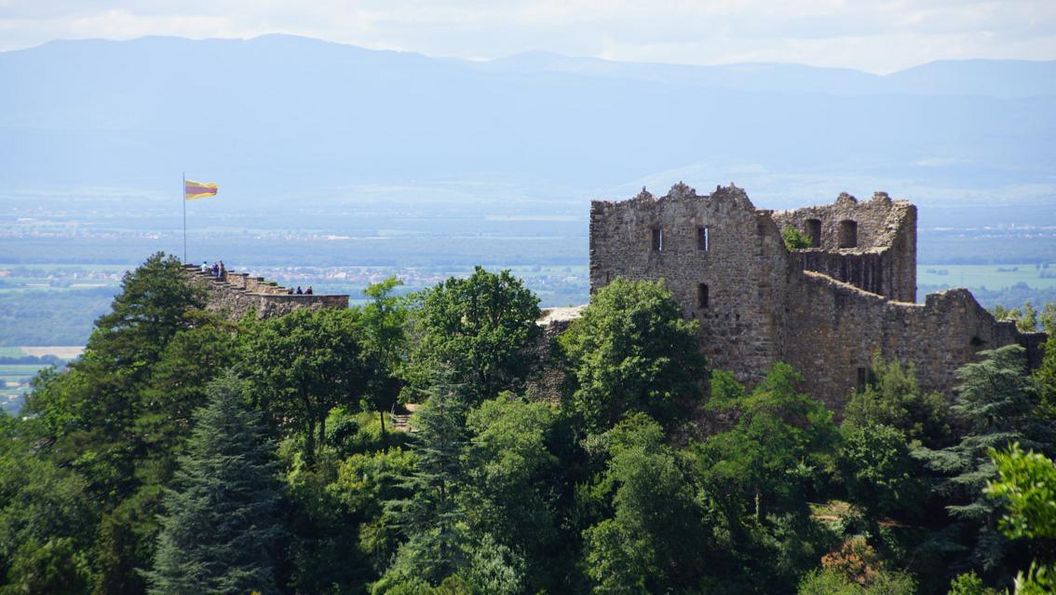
[24,253,204,506]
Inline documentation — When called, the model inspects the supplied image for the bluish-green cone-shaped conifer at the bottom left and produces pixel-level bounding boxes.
[147,373,282,594]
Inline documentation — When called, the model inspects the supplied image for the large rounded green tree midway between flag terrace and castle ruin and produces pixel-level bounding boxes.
[408,266,542,403]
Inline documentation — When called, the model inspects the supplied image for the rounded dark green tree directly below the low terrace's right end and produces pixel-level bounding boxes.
[243,309,367,463]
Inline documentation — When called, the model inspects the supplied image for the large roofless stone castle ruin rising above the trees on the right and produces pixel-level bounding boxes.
[590,183,1044,410]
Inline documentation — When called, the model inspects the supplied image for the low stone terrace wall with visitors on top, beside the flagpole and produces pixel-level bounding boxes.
[184,264,348,319]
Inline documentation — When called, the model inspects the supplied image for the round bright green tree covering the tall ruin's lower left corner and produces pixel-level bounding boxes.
[560,278,704,432]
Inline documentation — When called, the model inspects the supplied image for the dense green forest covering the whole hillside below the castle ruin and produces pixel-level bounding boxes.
[0,254,1056,594]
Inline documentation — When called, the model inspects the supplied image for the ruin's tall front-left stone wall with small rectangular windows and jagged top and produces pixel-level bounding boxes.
[590,184,789,380]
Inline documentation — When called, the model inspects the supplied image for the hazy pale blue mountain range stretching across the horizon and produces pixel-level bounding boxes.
[0,35,1056,206]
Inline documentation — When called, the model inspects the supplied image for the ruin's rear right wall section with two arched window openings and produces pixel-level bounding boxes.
[773,192,917,302]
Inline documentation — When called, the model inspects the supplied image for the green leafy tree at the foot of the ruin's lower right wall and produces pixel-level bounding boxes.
[844,354,950,448]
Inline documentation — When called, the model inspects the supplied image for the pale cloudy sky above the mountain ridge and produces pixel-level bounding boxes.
[0,0,1056,74]
